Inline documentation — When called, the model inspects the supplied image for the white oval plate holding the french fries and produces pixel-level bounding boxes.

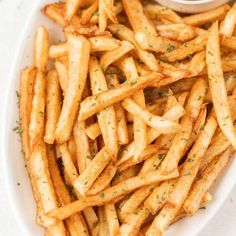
[1,0,236,236]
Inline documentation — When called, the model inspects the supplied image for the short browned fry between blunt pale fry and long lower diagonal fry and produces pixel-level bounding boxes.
[87,162,117,195]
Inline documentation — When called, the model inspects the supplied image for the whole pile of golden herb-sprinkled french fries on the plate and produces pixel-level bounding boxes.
[17,0,236,236]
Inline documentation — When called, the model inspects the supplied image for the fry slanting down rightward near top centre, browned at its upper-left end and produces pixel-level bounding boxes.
[108,24,159,71]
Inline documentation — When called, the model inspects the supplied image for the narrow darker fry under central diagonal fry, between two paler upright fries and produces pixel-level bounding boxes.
[106,71,129,145]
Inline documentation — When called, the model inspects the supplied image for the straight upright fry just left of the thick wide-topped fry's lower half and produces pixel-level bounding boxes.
[44,70,61,144]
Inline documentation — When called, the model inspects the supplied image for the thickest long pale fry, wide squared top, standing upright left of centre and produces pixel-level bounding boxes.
[55,35,90,144]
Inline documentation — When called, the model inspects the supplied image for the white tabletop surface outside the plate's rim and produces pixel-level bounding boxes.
[0,0,236,236]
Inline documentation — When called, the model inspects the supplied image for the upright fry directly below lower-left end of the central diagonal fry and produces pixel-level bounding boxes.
[73,120,93,174]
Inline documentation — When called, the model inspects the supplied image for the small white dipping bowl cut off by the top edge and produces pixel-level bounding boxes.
[155,0,229,13]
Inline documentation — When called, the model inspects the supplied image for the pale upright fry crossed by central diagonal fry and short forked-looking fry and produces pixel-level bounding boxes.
[121,57,147,160]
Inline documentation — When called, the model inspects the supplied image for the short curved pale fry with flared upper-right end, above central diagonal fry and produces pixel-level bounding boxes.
[100,41,134,71]
